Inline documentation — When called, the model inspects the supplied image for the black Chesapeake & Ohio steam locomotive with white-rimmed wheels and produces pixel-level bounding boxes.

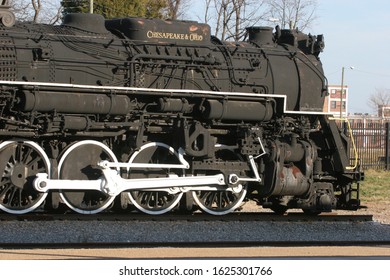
[0,10,362,215]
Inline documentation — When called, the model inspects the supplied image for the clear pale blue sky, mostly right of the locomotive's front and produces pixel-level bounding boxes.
[187,0,390,114]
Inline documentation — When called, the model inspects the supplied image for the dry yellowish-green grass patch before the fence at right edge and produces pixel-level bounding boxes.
[360,169,390,203]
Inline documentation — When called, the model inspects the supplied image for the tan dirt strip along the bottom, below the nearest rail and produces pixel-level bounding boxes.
[0,246,390,260]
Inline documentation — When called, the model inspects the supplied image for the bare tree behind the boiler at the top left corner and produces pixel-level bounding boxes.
[11,0,61,24]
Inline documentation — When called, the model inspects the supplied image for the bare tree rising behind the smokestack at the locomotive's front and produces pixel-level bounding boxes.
[266,0,317,31]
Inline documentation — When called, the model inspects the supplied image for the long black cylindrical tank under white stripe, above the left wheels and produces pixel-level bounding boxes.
[19,91,131,115]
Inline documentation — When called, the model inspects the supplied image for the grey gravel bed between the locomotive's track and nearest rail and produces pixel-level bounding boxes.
[0,221,390,247]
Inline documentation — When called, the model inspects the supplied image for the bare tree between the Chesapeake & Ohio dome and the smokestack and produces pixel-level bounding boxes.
[204,0,265,41]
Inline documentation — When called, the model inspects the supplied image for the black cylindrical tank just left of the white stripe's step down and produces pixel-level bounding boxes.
[203,100,273,121]
